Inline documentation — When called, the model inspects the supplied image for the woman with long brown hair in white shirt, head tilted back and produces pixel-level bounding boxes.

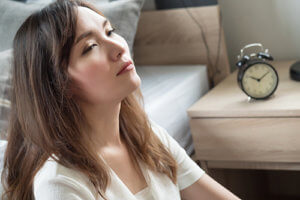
[2,0,238,200]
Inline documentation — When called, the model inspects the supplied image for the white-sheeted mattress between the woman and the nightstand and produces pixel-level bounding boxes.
[136,65,209,155]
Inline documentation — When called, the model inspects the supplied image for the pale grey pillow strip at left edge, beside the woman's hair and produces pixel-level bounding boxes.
[0,49,12,139]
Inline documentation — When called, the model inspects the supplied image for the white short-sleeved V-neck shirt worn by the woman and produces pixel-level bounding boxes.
[33,120,205,200]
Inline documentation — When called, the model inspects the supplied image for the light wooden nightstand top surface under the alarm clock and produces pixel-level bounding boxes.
[187,61,300,118]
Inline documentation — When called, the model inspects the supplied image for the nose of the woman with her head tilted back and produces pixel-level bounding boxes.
[107,40,126,61]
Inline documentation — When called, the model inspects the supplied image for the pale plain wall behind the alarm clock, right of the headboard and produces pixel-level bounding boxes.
[219,0,300,70]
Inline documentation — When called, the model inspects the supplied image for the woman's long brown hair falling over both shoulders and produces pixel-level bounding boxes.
[1,0,177,200]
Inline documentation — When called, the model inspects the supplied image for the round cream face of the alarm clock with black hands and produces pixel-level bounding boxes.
[242,63,278,99]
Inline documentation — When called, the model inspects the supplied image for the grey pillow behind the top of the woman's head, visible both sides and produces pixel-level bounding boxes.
[0,0,145,57]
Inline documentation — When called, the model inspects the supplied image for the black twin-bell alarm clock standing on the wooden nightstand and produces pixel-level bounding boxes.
[236,43,279,100]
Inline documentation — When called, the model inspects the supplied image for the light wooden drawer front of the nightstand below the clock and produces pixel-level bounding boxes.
[190,117,300,162]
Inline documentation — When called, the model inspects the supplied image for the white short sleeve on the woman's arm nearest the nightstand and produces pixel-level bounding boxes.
[150,120,205,190]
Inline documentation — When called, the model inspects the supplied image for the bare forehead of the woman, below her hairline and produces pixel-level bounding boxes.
[76,6,106,34]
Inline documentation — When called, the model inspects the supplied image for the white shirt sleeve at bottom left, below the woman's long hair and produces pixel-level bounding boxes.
[34,176,95,200]
